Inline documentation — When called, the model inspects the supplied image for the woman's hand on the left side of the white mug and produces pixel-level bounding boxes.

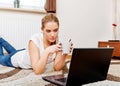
[46,44,62,54]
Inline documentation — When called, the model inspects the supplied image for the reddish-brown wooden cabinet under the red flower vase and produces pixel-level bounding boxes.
[98,41,120,57]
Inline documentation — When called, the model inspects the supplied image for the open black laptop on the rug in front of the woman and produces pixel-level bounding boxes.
[42,48,113,86]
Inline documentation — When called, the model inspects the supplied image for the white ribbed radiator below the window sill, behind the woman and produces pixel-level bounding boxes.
[0,11,43,49]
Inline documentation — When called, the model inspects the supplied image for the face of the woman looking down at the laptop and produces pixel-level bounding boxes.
[43,21,59,43]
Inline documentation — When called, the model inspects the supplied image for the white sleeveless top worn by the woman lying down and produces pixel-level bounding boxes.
[11,32,56,69]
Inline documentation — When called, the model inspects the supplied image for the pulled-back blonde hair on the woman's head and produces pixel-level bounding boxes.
[41,13,59,30]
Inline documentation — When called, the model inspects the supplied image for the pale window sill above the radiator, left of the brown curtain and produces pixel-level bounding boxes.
[0,7,47,14]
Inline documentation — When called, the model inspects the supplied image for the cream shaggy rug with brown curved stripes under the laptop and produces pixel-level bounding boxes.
[0,59,120,86]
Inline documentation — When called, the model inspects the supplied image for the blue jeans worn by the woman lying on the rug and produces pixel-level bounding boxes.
[0,38,24,67]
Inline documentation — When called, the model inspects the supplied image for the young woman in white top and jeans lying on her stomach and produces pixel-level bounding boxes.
[0,14,72,74]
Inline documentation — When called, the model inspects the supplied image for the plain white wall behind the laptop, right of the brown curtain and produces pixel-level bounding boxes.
[57,0,112,47]
